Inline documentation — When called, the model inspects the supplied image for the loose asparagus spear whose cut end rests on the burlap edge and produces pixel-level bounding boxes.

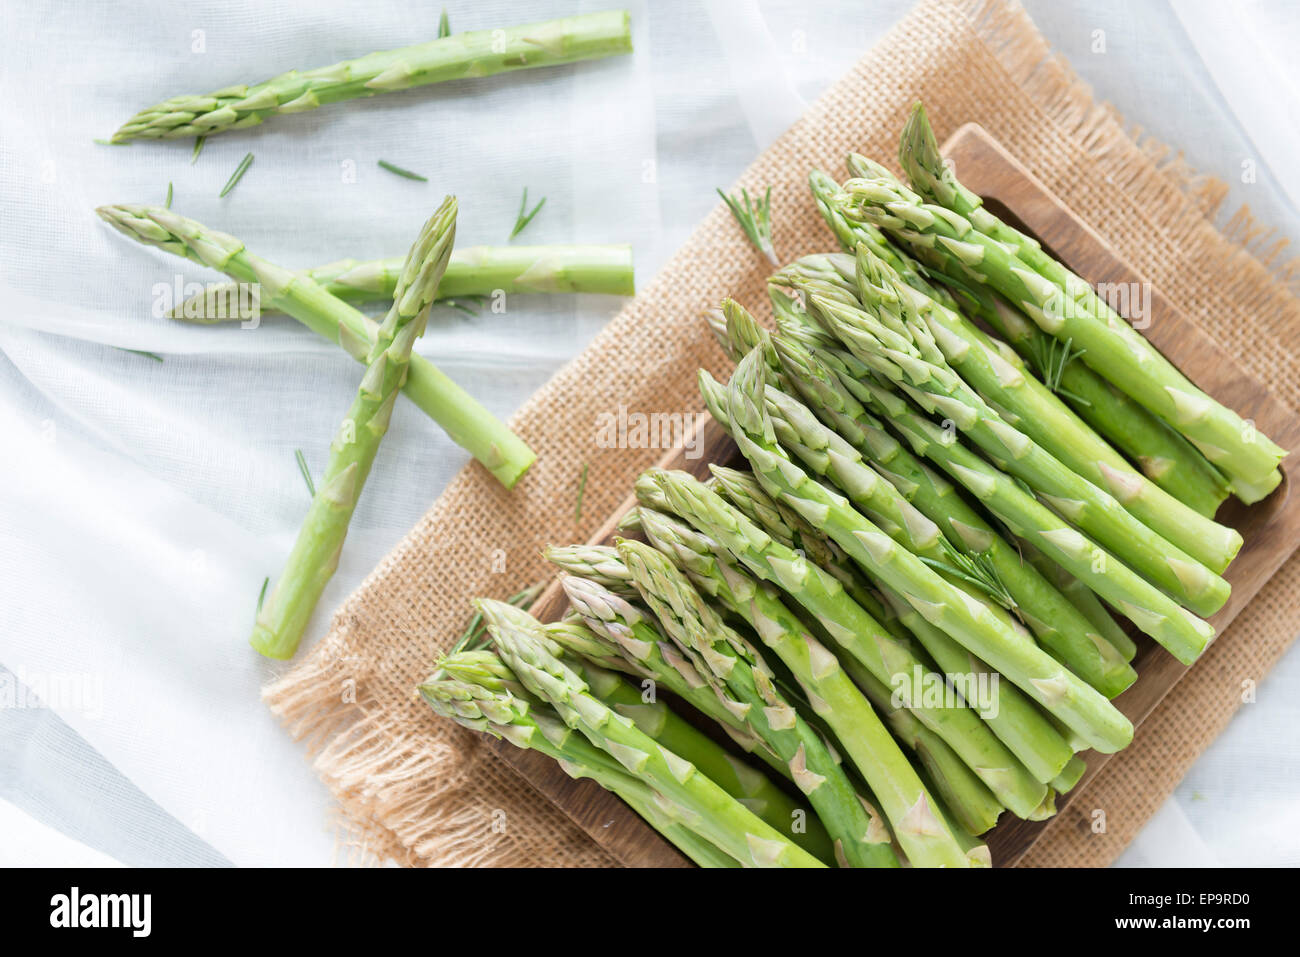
[96,205,537,489]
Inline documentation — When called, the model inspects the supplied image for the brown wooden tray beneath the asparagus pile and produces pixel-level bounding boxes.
[494,124,1300,867]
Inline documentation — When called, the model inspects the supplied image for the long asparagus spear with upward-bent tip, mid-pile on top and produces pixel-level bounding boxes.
[727,350,1132,748]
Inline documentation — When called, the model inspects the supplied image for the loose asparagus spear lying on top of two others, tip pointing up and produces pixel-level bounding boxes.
[251,196,456,658]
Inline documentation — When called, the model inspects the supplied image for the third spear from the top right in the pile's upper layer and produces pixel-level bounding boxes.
[813,280,1231,615]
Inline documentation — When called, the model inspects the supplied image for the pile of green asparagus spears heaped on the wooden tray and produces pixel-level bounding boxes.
[426,107,1282,867]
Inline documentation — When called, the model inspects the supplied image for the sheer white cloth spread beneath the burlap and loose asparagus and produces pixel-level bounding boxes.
[0,0,1300,865]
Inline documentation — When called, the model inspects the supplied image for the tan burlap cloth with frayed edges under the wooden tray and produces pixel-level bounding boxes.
[267,0,1300,866]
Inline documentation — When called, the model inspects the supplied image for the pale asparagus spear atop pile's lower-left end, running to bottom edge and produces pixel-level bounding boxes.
[480,599,823,867]
